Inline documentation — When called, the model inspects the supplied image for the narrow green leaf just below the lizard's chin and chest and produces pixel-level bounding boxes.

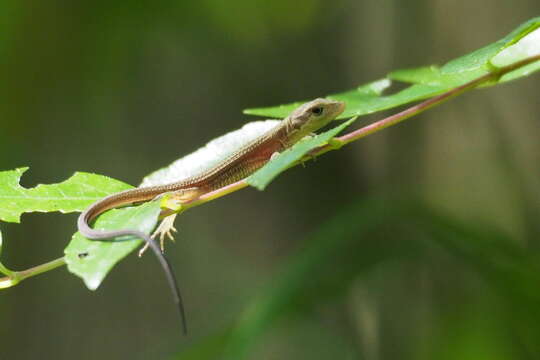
[246,118,356,190]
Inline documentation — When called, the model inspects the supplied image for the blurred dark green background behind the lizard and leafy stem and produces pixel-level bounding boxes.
[0,0,540,360]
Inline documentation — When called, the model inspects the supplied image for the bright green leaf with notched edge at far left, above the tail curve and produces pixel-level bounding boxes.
[0,167,130,223]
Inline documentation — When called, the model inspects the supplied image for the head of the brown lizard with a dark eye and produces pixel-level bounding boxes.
[287,98,345,136]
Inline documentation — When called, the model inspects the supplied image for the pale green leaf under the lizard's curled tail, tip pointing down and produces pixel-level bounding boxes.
[64,201,161,290]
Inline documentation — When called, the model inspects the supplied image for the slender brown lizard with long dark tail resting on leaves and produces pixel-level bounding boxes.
[77,98,345,333]
